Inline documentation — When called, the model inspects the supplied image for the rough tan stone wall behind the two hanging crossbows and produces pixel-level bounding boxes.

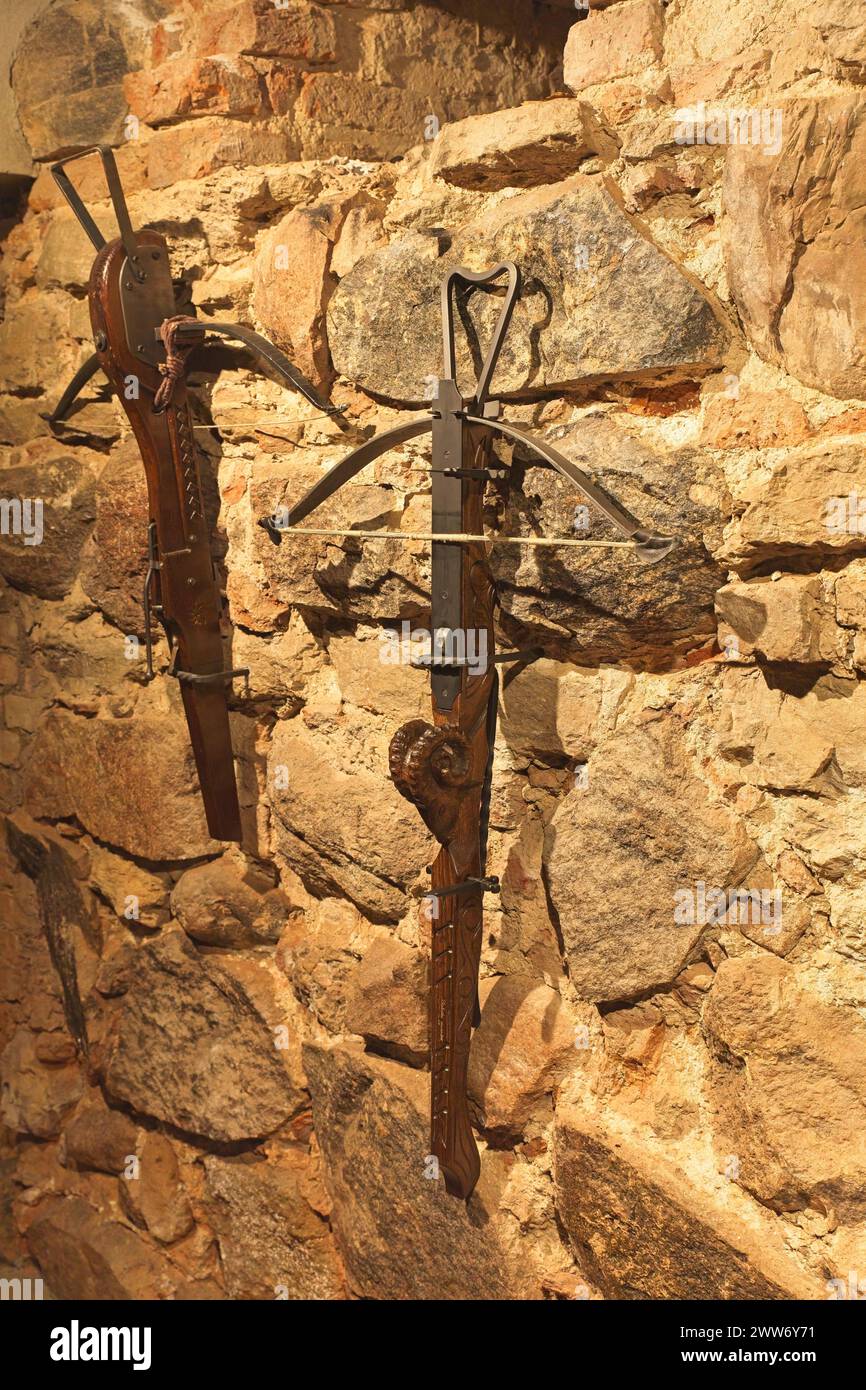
[0,0,866,1300]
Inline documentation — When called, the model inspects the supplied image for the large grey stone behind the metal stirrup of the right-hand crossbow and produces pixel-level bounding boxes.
[328,175,728,403]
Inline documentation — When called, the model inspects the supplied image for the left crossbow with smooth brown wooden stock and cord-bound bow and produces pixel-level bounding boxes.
[47,145,342,841]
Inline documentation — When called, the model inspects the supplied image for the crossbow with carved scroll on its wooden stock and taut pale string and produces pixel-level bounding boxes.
[260,261,676,1200]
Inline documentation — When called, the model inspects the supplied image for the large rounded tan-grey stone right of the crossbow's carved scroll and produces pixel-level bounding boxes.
[545,714,758,1002]
